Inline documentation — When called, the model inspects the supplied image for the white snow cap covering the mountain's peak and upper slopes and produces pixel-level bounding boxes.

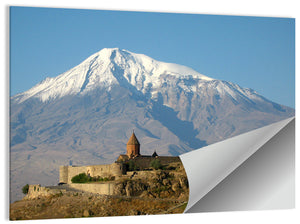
[14,48,214,102]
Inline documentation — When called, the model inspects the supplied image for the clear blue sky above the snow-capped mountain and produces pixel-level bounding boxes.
[10,7,295,107]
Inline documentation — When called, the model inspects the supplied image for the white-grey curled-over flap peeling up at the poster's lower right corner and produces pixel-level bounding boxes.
[180,117,294,212]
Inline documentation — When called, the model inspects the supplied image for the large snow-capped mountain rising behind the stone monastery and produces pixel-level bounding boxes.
[10,48,295,201]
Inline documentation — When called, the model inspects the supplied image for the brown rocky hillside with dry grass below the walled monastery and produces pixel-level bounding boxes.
[10,162,189,220]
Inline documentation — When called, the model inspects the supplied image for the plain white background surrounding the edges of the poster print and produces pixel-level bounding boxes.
[0,0,299,224]
